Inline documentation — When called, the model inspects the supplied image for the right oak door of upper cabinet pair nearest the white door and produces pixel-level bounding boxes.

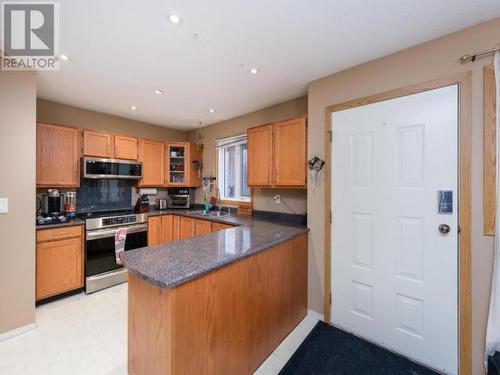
[274,117,307,186]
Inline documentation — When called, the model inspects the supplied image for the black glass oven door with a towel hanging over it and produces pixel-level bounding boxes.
[85,224,148,277]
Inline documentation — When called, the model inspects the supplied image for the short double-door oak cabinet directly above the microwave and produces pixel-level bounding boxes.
[83,130,138,160]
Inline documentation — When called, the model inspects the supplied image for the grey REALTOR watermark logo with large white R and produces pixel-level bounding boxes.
[1,1,59,70]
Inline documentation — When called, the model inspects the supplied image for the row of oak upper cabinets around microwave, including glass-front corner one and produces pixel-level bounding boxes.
[36,123,197,187]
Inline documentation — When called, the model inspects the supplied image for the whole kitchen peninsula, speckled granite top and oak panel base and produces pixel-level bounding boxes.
[122,212,307,375]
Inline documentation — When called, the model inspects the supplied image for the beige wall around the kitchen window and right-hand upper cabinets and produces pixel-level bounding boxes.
[189,96,307,213]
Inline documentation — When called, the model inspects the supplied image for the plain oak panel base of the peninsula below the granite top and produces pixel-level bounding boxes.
[128,234,307,375]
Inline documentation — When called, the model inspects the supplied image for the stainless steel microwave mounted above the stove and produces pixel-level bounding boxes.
[82,157,142,180]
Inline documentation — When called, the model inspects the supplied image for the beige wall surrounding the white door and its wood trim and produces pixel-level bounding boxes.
[308,18,500,374]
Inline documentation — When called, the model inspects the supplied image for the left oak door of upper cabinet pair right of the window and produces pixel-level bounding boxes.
[247,124,274,186]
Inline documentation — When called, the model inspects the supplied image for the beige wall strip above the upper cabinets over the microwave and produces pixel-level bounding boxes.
[36,99,187,141]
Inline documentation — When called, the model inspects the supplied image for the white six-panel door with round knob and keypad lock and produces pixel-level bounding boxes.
[331,85,458,374]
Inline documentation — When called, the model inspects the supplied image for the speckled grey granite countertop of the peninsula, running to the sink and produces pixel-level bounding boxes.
[121,210,308,288]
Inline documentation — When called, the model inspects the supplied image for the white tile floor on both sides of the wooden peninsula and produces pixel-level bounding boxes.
[0,284,317,375]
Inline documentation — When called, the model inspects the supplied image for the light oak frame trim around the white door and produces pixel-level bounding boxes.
[323,71,472,375]
